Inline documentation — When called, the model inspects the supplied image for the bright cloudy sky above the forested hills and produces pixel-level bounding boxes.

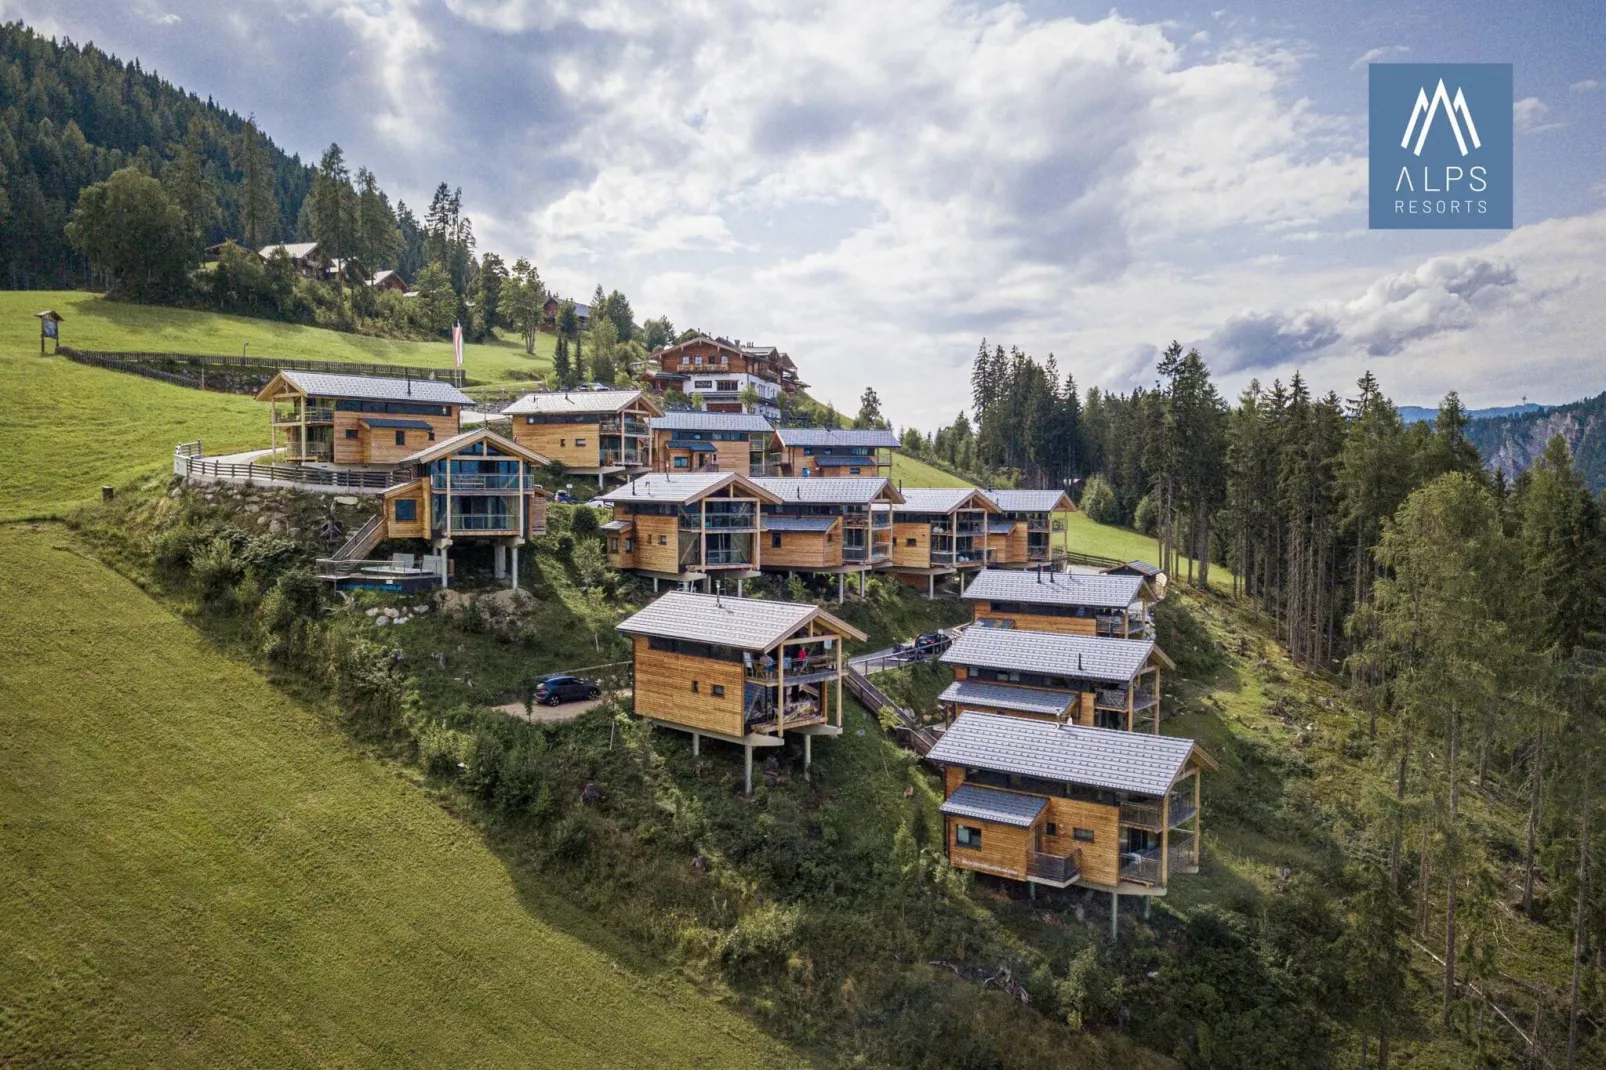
[0,0,1606,427]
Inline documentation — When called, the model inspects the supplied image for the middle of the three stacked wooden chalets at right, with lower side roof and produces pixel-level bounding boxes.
[938,625,1176,734]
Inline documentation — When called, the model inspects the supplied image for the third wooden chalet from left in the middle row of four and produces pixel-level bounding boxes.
[882,487,999,596]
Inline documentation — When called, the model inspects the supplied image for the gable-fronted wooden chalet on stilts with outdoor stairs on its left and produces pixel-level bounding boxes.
[361,427,548,586]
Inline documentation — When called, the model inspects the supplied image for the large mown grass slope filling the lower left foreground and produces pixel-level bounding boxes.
[0,526,799,1068]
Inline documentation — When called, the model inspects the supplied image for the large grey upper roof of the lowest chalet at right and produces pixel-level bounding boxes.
[927,713,1193,795]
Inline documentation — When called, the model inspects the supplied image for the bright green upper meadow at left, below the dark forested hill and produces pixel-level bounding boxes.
[0,291,552,521]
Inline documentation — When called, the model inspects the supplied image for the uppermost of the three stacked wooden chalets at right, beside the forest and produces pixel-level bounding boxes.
[960,567,1155,639]
